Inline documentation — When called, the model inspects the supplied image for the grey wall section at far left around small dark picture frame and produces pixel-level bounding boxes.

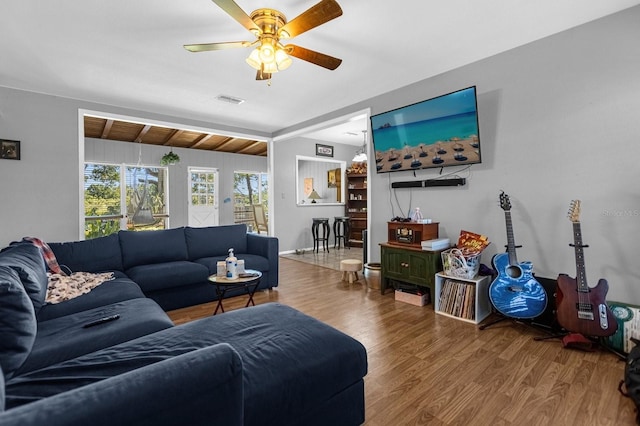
[0,88,80,243]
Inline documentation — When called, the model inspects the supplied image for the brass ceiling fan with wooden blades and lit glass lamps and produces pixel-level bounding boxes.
[184,0,342,80]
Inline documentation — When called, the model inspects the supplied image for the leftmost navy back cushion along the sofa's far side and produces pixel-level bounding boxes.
[48,234,124,272]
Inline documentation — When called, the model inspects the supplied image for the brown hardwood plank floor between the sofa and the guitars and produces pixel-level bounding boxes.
[169,258,635,426]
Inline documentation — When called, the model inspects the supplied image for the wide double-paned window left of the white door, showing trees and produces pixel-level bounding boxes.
[84,163,169,239]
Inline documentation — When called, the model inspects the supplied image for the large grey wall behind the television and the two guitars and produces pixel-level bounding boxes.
[276,7,640,304]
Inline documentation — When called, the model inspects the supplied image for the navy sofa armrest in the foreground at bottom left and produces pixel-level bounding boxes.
[0,343,244,426]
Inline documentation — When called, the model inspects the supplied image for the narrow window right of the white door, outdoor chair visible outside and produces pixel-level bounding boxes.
[233,172,269,231]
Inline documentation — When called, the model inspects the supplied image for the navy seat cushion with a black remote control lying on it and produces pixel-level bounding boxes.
[16,299,173,375]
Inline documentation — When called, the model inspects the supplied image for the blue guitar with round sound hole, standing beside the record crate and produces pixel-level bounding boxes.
[489,192,547,319]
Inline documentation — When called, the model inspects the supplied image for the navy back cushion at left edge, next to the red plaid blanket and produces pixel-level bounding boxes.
[0,243,48,313]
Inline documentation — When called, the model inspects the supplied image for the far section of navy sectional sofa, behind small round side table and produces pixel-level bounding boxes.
[49,224,278,311]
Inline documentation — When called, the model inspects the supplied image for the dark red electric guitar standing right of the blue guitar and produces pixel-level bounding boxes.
[556,200,618,337]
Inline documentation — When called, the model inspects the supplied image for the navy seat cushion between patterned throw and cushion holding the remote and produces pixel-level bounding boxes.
[36,278,145,321]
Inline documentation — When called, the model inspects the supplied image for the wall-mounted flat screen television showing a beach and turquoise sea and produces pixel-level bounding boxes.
[371,86,481,173]
